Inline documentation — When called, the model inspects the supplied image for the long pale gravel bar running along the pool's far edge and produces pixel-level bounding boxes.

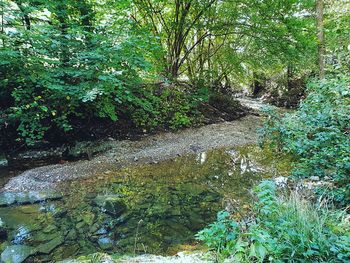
[0,115,262,192]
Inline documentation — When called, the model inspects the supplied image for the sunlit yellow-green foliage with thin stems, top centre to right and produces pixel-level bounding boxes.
[132,0,316,86]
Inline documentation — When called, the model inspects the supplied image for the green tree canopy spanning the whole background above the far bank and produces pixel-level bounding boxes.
[0,0,349,144]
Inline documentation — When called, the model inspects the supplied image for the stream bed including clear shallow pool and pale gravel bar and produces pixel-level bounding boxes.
[0,99,290,263]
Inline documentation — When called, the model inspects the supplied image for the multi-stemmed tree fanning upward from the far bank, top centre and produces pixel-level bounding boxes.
[132,0,217,80]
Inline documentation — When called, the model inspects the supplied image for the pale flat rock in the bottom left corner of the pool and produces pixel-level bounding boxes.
[1,245,36,263]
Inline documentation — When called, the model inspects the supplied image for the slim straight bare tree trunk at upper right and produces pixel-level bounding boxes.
[316,0,325,79]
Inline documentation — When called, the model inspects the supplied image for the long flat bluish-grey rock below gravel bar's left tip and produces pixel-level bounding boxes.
[0,191,63,207]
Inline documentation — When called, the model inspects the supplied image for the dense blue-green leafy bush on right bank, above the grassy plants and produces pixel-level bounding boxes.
[261,76,350,204]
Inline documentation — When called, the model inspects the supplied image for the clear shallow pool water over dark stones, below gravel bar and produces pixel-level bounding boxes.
[0,146,289,262]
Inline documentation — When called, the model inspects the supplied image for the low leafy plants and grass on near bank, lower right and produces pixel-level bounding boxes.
[197,181,350,262]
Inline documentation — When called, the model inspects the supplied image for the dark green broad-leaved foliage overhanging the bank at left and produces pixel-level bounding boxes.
[0,0,160,145]
